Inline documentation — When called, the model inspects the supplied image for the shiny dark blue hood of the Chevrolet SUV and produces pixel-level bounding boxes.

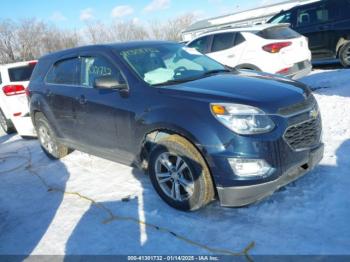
[160,71,311,113]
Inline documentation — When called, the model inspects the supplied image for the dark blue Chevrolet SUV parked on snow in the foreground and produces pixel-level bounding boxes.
[29,41,323,210]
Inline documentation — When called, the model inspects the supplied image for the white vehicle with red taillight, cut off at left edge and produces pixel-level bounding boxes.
[0,61,37,137]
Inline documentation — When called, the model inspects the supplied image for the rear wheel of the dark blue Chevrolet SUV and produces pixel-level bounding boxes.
[35,113,70,159]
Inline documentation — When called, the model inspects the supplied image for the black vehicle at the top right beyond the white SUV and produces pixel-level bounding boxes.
[268,0,350,67]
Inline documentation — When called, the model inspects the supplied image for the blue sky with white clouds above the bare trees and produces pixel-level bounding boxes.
[1,0,282,29]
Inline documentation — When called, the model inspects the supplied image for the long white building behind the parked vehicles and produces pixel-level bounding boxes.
[182,0,319,41]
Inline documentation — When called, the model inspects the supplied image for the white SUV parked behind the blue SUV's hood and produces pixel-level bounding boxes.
[187,24,312,79]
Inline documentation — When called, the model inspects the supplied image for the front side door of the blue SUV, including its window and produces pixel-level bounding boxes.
[75,53,132,162]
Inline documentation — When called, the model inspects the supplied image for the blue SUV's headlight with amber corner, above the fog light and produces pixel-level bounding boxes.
[210,103,275,135]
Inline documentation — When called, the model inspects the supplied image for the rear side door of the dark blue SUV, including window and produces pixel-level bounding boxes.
[44,55,80,141]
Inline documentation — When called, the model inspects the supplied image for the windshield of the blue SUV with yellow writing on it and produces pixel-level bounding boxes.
[120,44,227,85]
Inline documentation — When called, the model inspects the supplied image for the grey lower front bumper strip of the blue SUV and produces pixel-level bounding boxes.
[217,144,324,207]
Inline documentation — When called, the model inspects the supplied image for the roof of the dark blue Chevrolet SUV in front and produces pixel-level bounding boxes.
[40,41,179,59]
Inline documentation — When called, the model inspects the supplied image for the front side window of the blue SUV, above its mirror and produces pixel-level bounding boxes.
[80,56,126,88]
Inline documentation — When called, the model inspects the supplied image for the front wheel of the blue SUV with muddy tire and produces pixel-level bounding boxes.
[148,135,215,211]
